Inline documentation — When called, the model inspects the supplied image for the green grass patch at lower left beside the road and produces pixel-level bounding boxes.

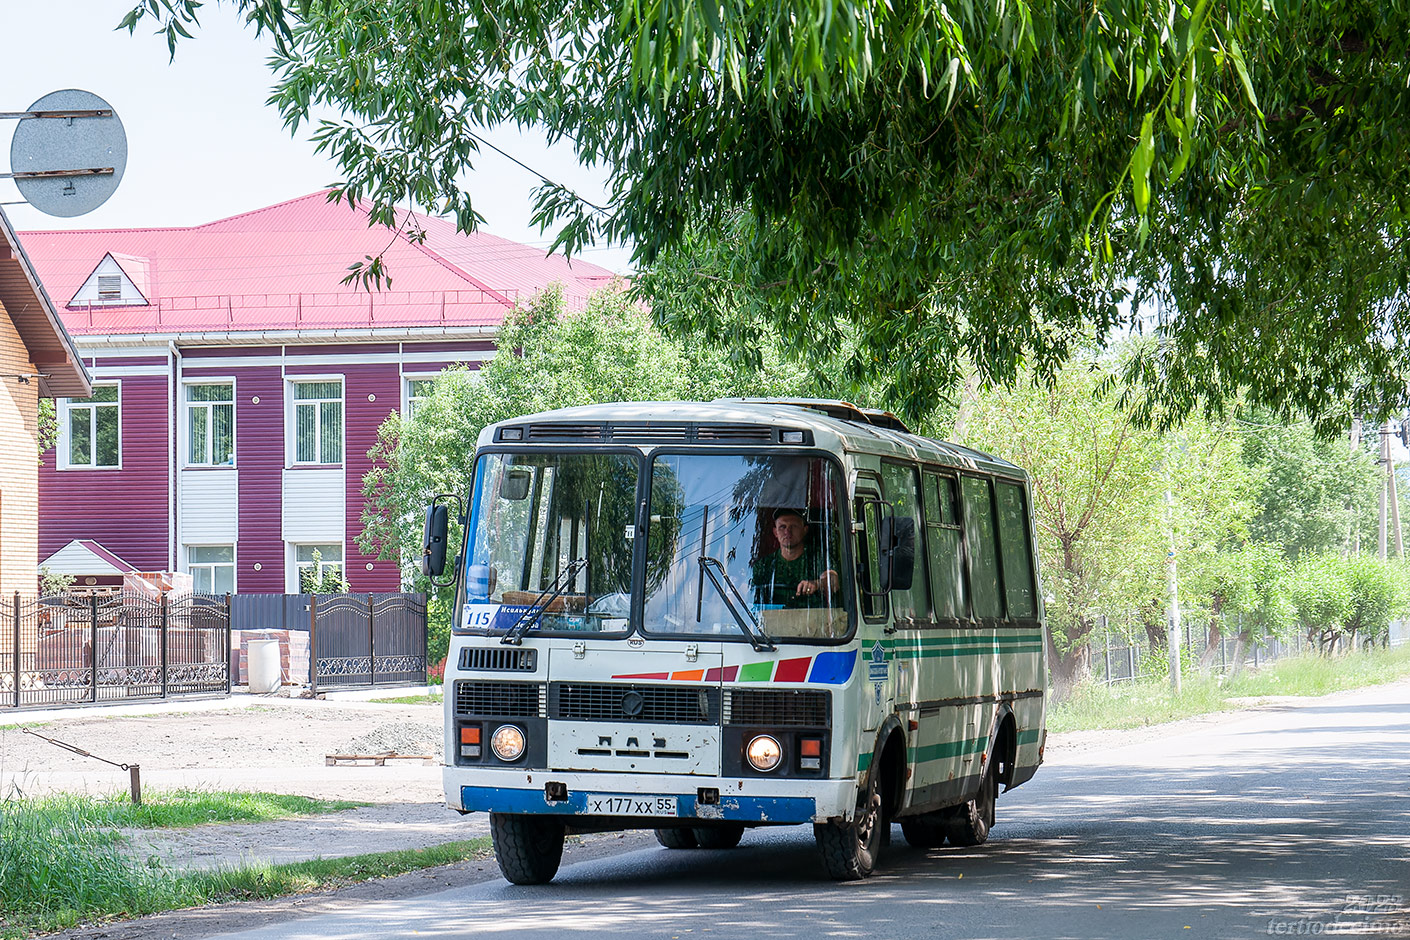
[0,793,489,940]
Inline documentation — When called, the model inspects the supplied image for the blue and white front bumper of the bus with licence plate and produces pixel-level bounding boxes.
[446,768,856,827]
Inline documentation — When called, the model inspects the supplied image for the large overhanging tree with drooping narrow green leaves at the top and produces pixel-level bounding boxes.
[124,0,1410,423]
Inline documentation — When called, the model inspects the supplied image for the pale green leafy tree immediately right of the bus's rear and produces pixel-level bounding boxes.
[962,357,1248,695]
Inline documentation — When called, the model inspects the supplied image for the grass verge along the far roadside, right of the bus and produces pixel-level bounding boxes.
[1048,645,1410,734]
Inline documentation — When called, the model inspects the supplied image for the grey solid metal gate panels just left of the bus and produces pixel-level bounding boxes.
[309,593,426,693]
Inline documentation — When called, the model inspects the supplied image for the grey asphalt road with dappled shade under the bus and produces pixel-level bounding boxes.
[170,684,1410,940]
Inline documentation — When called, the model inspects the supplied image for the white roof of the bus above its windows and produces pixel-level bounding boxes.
[478,399,1026,476]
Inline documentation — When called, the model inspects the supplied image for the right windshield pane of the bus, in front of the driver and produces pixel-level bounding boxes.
[642,454,852,640]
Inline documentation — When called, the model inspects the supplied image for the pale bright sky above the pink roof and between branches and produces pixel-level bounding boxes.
[0,0,630,272]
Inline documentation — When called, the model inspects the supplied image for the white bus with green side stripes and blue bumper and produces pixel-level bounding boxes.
[423,399,1046,884]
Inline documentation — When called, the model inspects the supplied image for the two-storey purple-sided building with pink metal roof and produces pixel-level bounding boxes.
[21,193,613,593]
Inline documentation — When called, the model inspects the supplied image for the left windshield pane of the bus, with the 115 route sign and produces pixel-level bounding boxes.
[458,452,640,633]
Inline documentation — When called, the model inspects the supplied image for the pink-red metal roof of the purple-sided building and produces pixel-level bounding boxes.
[20,192,613,334]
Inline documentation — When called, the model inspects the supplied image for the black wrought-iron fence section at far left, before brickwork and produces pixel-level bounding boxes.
[0,592,230,707]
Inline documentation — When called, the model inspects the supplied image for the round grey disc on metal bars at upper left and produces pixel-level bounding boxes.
[10,89,127,217]
